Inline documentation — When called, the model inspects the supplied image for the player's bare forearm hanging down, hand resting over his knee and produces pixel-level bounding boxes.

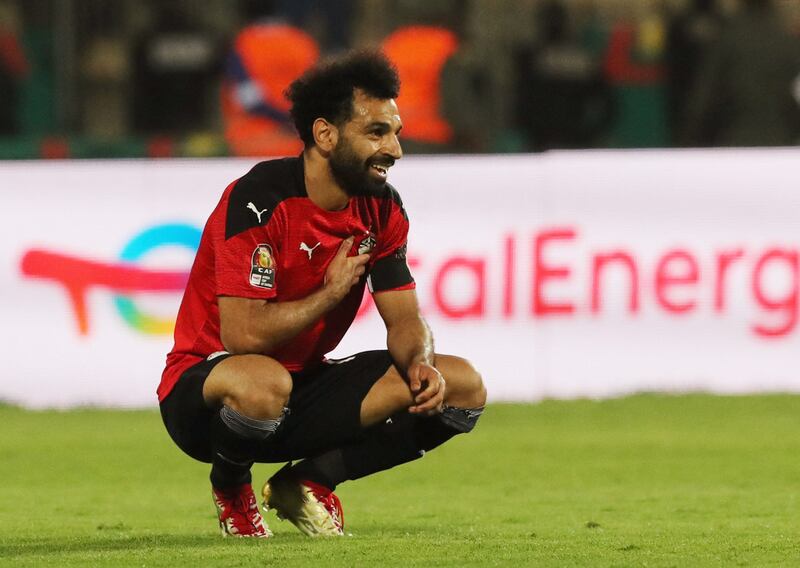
[374,290,445,415]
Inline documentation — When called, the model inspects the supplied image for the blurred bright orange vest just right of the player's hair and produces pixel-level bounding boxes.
[382,26,458,144]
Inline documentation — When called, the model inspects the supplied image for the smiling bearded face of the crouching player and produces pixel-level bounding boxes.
[329,89,403,196]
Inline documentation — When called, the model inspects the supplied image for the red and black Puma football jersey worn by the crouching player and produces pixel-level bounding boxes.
[158,157,414,401]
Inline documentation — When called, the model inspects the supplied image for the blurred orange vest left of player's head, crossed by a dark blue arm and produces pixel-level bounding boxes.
[222,22,319,157]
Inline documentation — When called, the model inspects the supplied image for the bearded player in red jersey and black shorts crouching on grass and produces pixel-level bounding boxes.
[158,51,486,537]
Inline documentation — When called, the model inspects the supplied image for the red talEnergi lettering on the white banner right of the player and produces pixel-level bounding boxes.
[356,233,800,338]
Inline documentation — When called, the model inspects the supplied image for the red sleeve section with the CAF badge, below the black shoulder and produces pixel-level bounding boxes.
[214,192,281,300]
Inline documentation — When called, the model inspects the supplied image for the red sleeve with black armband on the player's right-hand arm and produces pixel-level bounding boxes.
[367,197,416,294]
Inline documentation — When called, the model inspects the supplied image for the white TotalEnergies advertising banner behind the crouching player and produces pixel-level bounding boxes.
[0,150,800,407]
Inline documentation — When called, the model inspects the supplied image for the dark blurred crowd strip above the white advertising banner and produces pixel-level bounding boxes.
[0,0,800,159]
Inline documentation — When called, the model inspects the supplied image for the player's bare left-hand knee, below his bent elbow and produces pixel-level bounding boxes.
[203,355,292,419]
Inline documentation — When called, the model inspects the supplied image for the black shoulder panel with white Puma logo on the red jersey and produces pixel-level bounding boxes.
[225,158,306,240]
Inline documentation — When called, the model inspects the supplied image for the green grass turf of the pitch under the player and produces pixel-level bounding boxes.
[0,395,800,567]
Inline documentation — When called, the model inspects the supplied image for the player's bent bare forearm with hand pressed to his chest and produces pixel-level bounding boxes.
[217,237,369,354]
